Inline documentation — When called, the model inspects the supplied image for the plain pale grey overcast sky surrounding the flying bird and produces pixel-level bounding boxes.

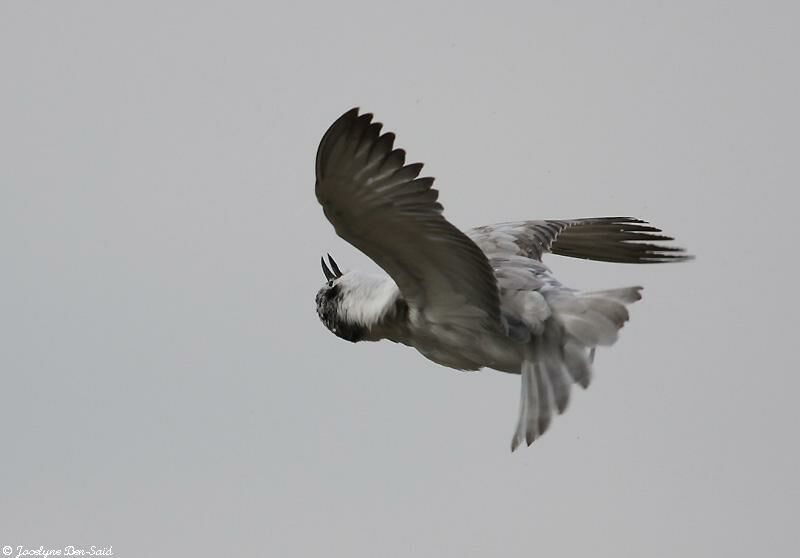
[0,0,800,557]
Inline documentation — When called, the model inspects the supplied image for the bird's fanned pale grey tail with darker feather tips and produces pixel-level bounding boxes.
[511,287,642,451]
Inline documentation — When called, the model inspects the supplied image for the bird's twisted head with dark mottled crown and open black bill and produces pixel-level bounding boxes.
[317,254,369,343]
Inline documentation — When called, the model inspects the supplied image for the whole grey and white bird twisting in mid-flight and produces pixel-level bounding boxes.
[315,108,692,452]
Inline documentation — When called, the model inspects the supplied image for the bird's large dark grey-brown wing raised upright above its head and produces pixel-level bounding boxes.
[316,109,500,327]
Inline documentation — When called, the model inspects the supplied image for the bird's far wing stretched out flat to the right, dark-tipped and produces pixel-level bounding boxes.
[466,217,691,263]
